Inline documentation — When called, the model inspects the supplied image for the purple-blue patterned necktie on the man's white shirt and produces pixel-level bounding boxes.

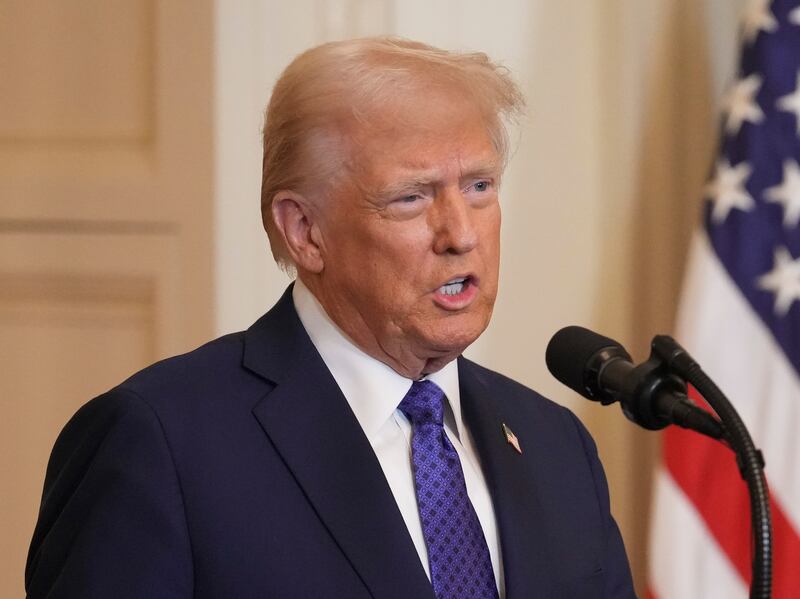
[399,381,497,599]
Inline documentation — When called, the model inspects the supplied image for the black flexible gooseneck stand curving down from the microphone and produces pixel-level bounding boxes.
[652,335,772,599]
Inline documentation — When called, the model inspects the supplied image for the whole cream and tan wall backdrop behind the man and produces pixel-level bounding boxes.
[0,0,741,597]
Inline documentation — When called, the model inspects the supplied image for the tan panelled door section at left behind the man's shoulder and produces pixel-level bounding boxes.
[0,0,213,597]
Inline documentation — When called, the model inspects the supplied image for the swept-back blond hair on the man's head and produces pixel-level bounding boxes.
[261,37,524,268]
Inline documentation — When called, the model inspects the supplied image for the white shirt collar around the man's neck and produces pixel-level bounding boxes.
[292,279,463,439]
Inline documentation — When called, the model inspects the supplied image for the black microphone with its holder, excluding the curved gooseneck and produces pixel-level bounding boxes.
[545,326,725,439]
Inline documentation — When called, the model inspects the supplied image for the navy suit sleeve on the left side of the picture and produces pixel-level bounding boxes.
[25,389,193,599]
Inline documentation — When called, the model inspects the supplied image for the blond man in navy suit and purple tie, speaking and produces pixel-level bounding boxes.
[26,38,633,599]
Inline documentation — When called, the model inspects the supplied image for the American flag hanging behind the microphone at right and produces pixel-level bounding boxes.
[648,0,800,599]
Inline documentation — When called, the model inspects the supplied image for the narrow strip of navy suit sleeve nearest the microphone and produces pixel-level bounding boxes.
[570,412,636,599]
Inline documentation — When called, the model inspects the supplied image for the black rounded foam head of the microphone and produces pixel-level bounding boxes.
[545,326,625,397]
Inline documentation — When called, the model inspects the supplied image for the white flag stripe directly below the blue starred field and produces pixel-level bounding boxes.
[677,232,800,530]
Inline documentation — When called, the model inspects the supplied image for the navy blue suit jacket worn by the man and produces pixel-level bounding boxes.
[26,292,633,599]
